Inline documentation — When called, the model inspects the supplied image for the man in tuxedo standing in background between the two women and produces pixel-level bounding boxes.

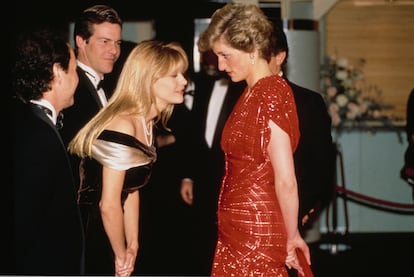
[181,51,245,275]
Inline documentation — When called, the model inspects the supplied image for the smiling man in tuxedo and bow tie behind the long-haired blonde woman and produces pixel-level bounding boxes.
[61,5,122,194]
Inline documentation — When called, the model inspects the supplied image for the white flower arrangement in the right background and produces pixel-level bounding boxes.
[321,56,392,127]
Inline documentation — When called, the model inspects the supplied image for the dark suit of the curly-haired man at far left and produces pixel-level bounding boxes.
[13,101,84,275]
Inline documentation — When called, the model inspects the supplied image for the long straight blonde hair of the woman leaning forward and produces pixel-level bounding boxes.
[68,40,188,158]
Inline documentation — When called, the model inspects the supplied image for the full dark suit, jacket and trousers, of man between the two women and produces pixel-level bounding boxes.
[188,73,245,275]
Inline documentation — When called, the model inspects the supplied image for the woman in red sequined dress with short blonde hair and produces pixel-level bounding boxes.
[198,3,310,276]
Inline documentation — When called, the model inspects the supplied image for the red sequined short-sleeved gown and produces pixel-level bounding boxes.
[212,75,300,277]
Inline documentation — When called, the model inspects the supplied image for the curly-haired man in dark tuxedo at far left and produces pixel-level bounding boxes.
[12,28,84,276]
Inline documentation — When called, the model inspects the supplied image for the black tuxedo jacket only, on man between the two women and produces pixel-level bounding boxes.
[189,73,245,217]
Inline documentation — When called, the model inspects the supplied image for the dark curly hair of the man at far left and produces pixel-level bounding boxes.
[12,28,70,103]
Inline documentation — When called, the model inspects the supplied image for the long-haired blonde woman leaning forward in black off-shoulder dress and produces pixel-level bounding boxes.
[69,40,188,276]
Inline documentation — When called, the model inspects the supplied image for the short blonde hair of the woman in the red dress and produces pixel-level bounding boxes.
[197,3,273,60]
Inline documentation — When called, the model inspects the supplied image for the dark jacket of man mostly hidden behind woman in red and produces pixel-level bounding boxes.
[288,81,336,224]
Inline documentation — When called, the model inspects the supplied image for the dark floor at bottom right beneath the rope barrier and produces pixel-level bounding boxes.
[302,231,414,277]
